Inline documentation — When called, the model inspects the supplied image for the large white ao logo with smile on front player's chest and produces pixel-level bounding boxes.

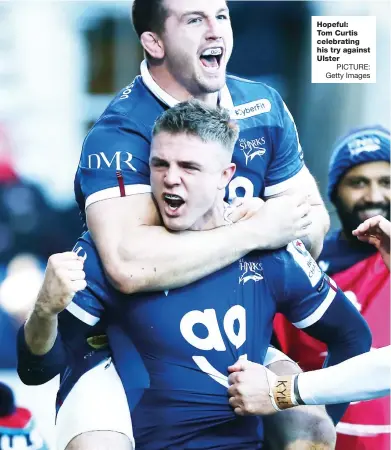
[180,305,246,388]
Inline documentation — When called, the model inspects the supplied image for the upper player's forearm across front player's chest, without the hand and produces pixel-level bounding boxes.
[105,222,258,294]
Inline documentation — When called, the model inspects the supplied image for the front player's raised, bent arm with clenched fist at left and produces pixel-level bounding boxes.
[17,252,100,385]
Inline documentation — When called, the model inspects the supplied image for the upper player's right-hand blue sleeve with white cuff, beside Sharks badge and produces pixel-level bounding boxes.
[265,89,304,197]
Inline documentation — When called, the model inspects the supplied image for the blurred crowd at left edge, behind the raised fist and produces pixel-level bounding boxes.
[0,129,81,370]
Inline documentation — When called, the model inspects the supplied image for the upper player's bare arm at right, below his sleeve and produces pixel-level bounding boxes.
[269,168,330,260]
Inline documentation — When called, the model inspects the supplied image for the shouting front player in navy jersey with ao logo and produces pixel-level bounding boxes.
[18,102,370,449]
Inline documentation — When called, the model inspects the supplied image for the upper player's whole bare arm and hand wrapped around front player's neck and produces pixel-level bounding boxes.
[87,194,310,294]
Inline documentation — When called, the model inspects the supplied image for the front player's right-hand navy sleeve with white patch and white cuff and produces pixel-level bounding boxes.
[268,240,338,329]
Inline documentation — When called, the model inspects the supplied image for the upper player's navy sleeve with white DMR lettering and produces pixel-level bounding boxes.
[75,113,151,208]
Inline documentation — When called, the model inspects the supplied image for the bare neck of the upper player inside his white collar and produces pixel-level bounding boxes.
[148,65,218,106]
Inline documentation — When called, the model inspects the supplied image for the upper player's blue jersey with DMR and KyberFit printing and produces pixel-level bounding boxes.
[75,62,305,227]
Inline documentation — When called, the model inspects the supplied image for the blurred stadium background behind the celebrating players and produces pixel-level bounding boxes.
[0,0,391,443]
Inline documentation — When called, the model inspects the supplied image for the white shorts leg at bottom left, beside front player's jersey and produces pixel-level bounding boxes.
[56,359,134,450]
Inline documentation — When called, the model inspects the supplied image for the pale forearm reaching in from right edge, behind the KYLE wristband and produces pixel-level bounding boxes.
[297,346,391,405]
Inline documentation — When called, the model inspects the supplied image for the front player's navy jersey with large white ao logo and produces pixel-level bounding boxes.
[60,233,336,450]
